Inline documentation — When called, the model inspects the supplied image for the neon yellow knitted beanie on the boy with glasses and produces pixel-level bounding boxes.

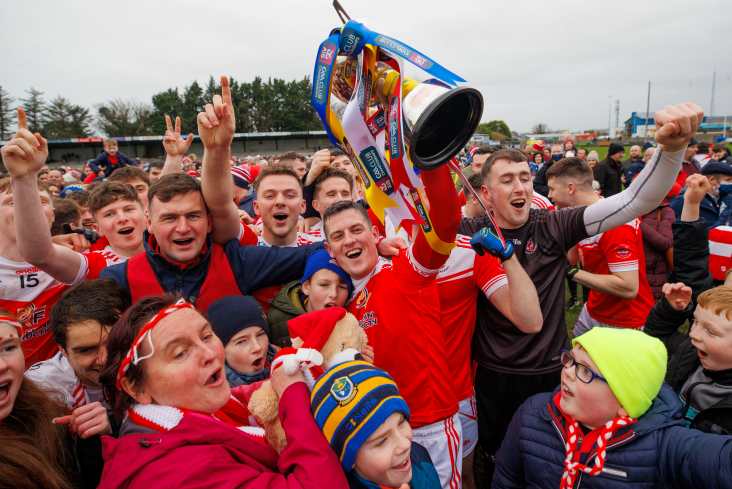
[572,327,668,418]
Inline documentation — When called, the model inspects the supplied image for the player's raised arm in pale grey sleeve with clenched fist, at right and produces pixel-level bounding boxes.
[584,103,704,236]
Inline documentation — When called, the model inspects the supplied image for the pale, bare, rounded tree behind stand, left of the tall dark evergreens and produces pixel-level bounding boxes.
[97,99,156,137]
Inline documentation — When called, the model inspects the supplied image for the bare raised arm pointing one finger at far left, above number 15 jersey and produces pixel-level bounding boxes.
[2,108,85,283]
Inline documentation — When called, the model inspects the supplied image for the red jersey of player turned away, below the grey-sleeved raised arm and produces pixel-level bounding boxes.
[577,219,653,328]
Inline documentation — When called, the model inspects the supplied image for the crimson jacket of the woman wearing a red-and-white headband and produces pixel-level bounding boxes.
[99,383,348,489]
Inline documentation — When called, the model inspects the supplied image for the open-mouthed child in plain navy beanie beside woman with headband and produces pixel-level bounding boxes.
[207,295,277,387]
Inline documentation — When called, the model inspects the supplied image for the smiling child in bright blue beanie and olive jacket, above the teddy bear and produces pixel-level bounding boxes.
[267,250,353,346]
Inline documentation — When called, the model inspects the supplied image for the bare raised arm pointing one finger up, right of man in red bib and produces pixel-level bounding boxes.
[198,76,241,244]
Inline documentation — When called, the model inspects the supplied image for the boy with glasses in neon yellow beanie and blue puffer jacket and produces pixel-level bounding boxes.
[492,328,732,489]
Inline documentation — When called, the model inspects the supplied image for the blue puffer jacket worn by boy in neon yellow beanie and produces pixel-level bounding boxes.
[492,385,732,489]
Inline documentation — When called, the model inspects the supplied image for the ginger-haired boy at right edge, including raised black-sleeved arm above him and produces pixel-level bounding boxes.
[645,174,732,435]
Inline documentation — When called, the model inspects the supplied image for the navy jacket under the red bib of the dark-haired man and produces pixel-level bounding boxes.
[100,232,323,301]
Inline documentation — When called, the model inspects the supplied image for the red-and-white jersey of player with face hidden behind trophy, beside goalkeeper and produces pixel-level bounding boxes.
[437,235,508,399]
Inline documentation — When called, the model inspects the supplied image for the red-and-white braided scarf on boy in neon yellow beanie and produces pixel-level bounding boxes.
[554,393,636,489]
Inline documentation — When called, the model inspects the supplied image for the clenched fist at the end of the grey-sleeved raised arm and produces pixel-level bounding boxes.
[654,102,704,151]
